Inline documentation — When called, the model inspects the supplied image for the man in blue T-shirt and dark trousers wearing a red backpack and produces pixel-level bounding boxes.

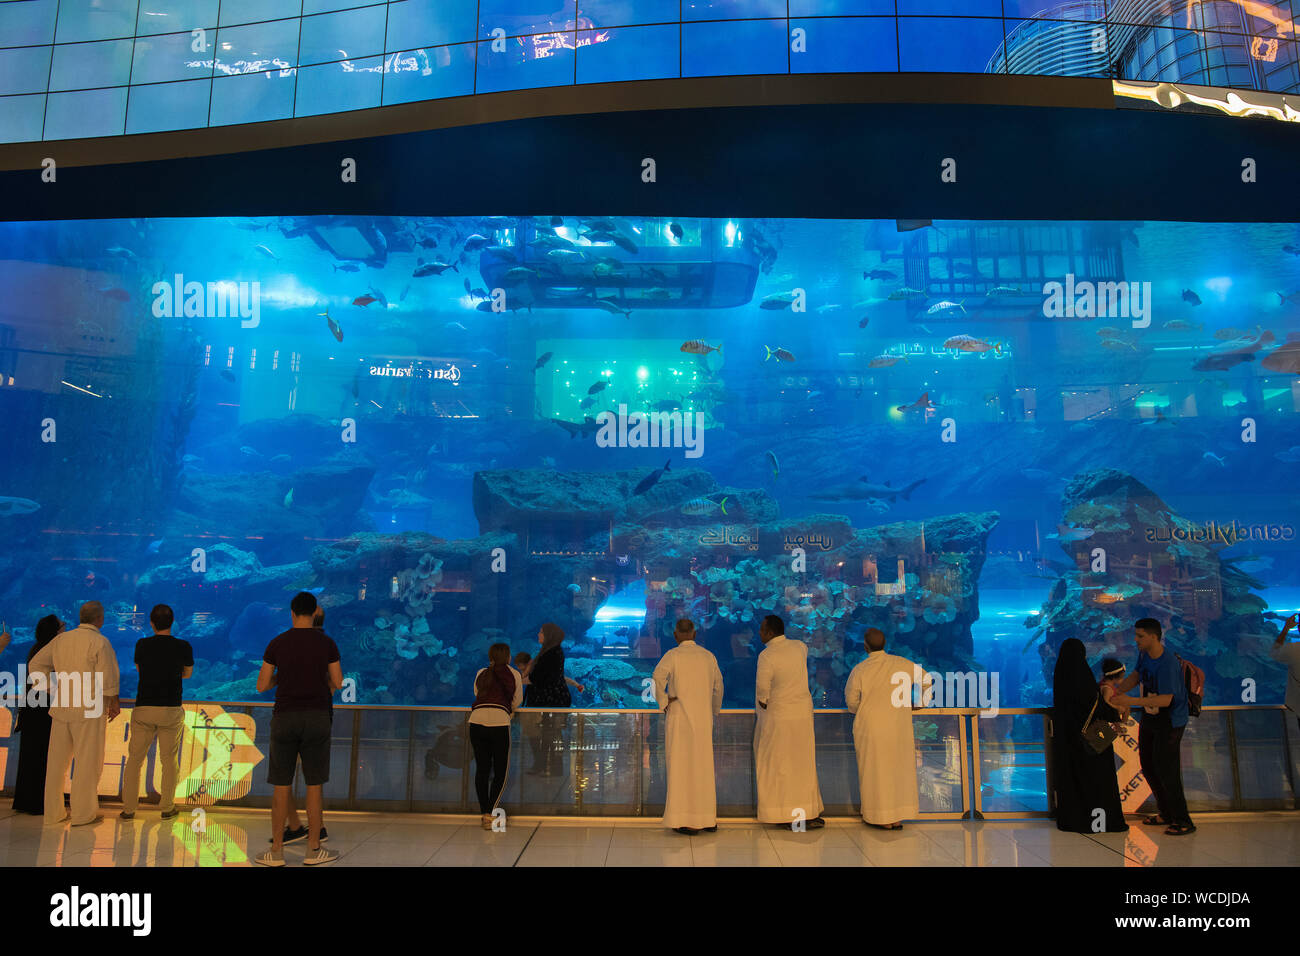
[1115,618,1196,836]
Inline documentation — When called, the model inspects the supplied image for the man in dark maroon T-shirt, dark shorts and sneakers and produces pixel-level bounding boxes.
[254,591,343,866]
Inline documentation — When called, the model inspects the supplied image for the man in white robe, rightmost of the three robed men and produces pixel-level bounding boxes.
[844,627,927,830]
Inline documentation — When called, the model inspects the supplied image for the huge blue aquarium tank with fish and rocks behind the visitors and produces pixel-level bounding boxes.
[0,217,1300,708]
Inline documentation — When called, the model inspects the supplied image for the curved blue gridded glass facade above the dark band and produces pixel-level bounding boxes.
[0,0,1300,142]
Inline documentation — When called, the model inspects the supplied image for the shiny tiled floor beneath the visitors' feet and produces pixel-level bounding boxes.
[0,808,1300,866]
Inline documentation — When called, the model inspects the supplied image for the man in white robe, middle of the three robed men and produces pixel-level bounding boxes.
[754,614,826,829]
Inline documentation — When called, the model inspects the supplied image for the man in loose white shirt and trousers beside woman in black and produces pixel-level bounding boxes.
[27,601,121,826]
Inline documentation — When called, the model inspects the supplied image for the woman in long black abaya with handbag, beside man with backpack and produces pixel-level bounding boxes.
[1052,637,1128,834]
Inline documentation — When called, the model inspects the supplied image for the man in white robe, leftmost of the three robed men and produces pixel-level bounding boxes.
[654,619,723,834]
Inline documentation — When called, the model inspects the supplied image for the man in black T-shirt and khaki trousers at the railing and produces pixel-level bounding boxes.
[121,604,194,819]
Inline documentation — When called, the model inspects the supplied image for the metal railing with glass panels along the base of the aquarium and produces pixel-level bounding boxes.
[4,701,1300,819]
